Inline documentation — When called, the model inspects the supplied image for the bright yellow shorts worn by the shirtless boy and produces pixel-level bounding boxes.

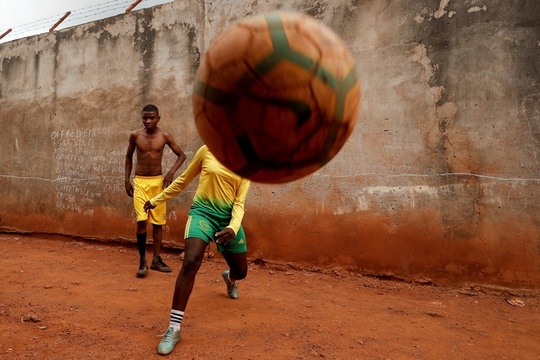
[133,175,167,225]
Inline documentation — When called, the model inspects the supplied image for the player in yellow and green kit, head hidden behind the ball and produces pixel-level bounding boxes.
[144,145,250,355]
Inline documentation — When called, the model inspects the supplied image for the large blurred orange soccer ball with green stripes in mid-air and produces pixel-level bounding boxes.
[193,12,360,183]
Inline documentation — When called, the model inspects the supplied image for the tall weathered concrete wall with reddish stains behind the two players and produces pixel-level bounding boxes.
[0,0,540,288]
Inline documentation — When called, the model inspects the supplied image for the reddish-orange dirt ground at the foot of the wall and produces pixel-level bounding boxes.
[0,234,540,360]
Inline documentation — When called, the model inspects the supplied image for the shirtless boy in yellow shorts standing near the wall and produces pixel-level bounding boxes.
[125,105,186,277]
